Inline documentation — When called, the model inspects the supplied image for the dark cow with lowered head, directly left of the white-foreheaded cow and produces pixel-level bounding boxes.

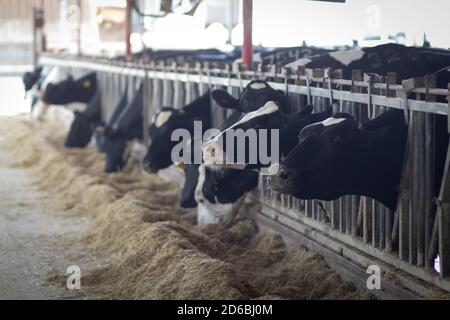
[103,83,144,173]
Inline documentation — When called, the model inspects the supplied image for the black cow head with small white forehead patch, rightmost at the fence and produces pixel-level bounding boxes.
[269,112,406,209]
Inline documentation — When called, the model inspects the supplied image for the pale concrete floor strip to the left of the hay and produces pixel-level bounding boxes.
[0,136,90,300]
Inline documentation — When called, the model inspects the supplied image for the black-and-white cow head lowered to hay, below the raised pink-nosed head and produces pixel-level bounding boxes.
[195,164,258,226]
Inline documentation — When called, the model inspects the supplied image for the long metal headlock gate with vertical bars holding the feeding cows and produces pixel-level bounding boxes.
[41,56,450,297]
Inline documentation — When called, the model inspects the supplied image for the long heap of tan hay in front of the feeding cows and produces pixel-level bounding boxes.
[0,117,371,299]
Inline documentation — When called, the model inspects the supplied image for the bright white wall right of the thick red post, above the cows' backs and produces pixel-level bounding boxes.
[254,0,450,48]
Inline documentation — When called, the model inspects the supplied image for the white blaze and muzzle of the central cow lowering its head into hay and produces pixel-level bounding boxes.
[195,165,246,225]
